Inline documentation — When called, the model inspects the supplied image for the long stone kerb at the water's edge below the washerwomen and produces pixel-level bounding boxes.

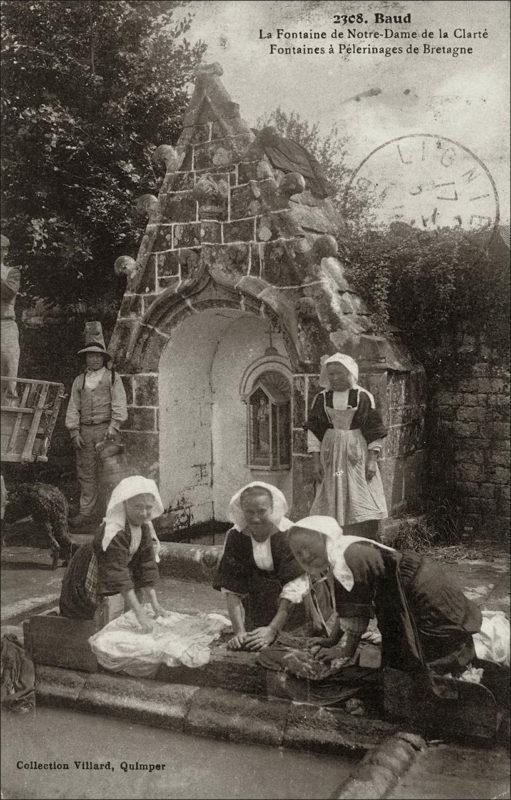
[36,667,404,756]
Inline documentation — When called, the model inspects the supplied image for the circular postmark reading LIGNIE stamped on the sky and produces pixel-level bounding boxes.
[344,133,499,243]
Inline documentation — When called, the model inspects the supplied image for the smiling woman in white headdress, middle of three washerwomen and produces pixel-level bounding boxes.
[213,481,302,650]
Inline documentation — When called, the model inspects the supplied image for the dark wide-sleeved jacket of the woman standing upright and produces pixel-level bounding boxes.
[303,387,387,444]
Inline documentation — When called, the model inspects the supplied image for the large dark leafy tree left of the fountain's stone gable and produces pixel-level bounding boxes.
[1,0,205,307]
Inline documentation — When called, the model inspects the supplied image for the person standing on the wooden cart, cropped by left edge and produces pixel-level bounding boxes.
[0,234,20,405]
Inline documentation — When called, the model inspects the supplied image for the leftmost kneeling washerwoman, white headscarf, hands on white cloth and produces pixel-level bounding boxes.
[60,475,170,632]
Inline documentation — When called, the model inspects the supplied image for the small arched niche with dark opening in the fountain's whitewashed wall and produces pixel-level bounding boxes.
[248,372,291,470]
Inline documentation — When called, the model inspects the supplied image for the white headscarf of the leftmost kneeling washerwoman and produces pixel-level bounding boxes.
[101,475,164,562]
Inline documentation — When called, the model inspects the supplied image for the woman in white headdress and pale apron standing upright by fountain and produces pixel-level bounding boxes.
[304,353,388,539]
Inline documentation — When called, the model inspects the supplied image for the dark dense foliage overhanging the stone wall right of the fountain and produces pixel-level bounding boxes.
[339,223,509,384]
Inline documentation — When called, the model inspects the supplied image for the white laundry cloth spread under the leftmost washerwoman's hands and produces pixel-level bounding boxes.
[89,605,231,678]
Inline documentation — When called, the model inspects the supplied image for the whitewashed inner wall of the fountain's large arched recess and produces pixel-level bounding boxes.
[159,307,292,524]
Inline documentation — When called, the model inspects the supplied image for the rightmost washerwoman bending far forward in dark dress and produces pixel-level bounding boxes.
[289,516,482,677]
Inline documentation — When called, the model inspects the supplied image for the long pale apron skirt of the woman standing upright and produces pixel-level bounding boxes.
[310,428,388,527]
